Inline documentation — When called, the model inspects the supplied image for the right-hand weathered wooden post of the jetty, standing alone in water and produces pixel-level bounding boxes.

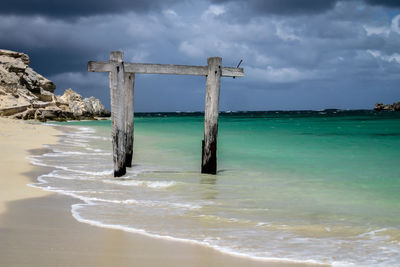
[201,57,222,174]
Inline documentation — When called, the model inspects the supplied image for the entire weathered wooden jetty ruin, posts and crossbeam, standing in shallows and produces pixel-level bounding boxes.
[88,51,244,177]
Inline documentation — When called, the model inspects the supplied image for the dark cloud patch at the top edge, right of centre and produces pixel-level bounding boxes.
[212,0,337,15]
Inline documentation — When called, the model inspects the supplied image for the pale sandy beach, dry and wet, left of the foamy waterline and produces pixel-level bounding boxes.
[0,119,320,267]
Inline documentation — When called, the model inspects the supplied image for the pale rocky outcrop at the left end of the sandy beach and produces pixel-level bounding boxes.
[0,49,111,121]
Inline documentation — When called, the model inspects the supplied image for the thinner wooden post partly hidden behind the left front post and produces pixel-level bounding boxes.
[124,72,135,167]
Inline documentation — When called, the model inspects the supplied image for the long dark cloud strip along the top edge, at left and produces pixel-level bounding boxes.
[0,0,175,18]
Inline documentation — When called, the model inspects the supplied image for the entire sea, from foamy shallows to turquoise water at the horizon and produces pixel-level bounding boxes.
[31,110,400,266]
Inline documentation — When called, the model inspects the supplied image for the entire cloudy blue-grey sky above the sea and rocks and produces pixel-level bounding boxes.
[0,0,400,112]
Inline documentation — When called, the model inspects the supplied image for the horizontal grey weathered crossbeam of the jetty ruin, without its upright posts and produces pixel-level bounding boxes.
[88,61,244,77]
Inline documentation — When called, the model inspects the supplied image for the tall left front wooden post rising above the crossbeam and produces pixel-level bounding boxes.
[109,52,126,177]
